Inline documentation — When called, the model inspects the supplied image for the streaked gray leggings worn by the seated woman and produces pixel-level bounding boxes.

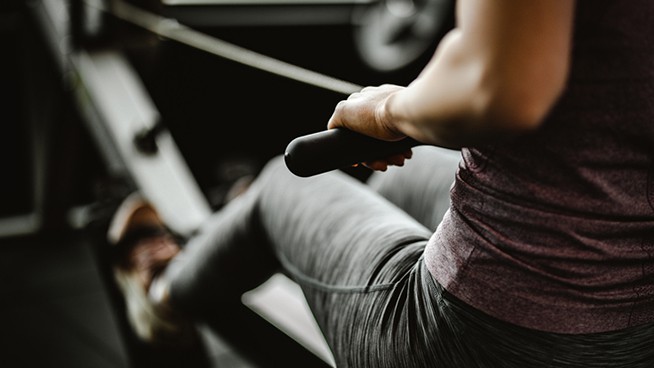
[167,147,654,368]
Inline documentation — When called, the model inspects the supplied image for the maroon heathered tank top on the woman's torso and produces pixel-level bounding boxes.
[426,0,654,333]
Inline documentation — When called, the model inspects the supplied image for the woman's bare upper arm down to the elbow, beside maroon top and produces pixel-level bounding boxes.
[457,0,575,128]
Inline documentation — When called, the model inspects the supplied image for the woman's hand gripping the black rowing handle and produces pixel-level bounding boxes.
[327,84,412,171]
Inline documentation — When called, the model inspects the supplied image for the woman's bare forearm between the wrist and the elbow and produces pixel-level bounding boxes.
[380,30,498,148]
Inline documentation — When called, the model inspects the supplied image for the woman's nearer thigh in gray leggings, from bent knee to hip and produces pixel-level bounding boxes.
[256,159,456,367]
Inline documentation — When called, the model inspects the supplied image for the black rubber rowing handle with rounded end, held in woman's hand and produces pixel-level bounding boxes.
[284,129,422,177]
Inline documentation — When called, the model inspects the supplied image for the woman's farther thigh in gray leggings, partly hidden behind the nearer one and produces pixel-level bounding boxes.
[368,146,461,230]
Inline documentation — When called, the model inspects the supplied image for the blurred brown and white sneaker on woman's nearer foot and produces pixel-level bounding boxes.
[108,194,198,348]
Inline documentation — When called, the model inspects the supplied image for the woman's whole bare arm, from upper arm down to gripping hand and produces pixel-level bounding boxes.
[328,0,575,152]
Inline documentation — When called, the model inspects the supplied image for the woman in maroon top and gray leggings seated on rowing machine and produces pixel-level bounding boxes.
[112,0,654,367]
